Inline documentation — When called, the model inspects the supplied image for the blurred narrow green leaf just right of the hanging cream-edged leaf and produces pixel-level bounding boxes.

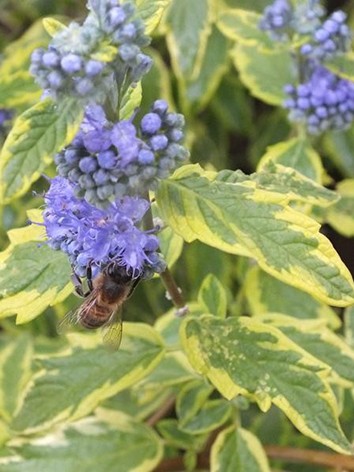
[185,26,229,110]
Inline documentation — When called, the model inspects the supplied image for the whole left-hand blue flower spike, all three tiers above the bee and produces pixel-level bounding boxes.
[35,0,188,278]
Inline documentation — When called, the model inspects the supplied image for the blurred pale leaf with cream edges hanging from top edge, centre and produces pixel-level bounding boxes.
[166,0,212,82]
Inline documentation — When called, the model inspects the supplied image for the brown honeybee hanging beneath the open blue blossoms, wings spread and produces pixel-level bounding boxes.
[58,263,139,350]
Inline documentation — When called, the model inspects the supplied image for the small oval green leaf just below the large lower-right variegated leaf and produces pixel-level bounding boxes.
[180,399,232,434]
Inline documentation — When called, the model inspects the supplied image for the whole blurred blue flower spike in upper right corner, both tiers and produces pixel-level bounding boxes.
[260,0,354,134]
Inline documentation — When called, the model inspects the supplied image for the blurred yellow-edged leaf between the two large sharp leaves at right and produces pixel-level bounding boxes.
[243,267,341,329]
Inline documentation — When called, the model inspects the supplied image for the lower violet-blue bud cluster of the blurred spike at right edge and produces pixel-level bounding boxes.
[284,66,354,134]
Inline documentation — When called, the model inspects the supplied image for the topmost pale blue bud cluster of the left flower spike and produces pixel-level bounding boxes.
[30,0,152,103]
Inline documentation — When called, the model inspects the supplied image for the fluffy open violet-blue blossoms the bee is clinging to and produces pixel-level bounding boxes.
[43,177,165,277]
